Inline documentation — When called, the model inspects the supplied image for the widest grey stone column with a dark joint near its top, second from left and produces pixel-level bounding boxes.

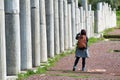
[5,0,20,75]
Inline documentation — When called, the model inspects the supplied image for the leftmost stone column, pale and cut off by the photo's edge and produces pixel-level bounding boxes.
[0,0,6,80]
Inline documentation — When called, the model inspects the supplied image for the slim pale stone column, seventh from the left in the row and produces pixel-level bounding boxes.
[54,0,60,54]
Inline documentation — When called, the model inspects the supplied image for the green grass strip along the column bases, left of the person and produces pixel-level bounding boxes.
[17,49,75,80]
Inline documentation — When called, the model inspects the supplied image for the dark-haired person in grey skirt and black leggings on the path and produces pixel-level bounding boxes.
[73,29,89,71]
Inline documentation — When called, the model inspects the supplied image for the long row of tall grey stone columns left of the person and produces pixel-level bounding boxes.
[0,0,115,80]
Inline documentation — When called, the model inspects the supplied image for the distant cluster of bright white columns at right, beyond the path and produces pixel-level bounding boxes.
[96,2,116,33]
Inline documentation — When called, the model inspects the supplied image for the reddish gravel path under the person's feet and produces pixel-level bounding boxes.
[26,29,120,80]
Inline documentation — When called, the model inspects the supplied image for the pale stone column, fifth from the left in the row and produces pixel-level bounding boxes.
[40,0,47,62]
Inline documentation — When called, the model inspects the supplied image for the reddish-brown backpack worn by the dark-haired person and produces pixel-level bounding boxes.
[77,35,86,49]
